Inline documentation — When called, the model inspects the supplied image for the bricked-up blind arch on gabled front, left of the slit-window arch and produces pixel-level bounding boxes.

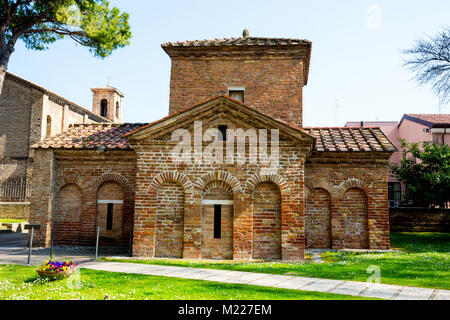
[155,181,184,258]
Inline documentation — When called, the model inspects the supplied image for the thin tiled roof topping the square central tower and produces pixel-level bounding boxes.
[161,37,311,48]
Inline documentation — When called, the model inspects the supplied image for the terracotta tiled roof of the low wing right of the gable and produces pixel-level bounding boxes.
[303,127,397,152]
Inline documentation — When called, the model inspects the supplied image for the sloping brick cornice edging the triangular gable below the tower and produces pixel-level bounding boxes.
[124,96,315,143]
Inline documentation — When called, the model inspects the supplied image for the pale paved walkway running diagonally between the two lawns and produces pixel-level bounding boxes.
[80,261,450,300]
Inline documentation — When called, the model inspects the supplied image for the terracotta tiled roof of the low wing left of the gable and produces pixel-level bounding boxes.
[32,123,145,150]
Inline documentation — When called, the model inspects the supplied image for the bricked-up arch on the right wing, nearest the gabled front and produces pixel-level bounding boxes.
[305,188,331,249]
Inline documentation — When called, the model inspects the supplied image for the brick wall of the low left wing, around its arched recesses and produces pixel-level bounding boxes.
[30,149,136,247]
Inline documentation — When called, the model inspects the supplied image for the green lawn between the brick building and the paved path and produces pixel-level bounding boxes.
[102,233,450,289]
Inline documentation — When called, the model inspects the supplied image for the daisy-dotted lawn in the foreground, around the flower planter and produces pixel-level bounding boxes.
[0,265,370,300]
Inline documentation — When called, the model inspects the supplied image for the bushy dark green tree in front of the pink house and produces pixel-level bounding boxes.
[391,140,450,208]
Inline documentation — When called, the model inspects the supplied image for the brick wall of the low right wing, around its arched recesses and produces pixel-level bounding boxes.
[305,153,390,249]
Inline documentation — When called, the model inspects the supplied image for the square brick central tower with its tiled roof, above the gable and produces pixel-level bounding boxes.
[162,30,311,127]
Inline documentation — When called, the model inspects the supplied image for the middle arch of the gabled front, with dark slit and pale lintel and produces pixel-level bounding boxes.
[201,183,233,259]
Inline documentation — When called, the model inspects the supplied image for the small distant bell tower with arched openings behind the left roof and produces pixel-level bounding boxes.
[91,86,124,123]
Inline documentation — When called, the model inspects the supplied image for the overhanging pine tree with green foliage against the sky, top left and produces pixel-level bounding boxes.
[0,0,131,94]
